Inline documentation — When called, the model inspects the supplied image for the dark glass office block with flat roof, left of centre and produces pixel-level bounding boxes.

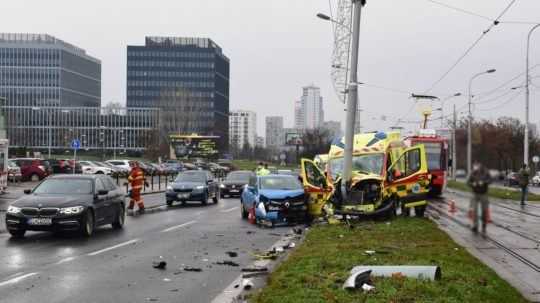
[127,37,229,150]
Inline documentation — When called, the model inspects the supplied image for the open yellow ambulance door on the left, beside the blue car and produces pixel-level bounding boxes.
[301,159,334,217]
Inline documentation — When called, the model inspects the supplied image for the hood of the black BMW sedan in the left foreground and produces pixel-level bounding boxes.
[11,194,94,207]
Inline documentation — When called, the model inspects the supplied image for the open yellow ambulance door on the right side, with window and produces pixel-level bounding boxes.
[385,145,430,208]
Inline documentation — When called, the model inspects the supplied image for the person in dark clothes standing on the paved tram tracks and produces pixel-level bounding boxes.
[467,162,491,234]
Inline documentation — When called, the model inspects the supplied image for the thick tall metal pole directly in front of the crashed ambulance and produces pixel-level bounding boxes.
[342,0,363,188]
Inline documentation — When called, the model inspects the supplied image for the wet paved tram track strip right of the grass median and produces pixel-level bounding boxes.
[428,190,540,302]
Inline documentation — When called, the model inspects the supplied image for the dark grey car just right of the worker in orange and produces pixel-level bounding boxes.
[165,170,220,206]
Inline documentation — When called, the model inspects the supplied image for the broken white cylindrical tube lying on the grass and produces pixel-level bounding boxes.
[351,265,441,280]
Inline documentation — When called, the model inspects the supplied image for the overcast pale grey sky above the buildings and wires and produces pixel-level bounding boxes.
[0,0,540,135]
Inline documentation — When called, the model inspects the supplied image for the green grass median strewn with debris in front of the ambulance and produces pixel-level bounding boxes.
[250,218,527,303]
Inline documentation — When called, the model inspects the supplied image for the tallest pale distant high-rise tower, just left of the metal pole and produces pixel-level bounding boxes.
[294,85,324,129]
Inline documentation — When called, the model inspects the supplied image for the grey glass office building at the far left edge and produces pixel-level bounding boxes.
[0,33,101,107]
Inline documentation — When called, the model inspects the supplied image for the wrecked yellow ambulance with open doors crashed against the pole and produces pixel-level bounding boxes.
[302,132,430,217]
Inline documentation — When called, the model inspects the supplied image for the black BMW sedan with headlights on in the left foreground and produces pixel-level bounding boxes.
[6,175,125,237]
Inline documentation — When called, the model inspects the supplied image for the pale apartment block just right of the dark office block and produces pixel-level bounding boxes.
[229,110,257,148]
